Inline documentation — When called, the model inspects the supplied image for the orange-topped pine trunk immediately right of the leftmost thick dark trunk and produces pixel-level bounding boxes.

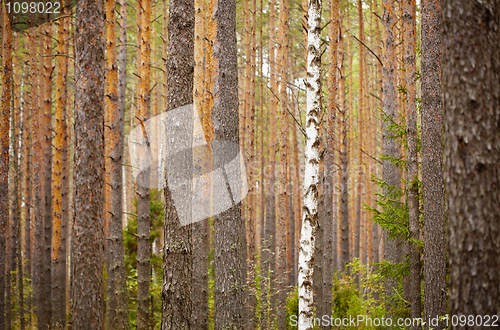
[104,0,130,330]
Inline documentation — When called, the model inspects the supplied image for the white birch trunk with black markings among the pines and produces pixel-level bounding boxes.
[299,0,322,330]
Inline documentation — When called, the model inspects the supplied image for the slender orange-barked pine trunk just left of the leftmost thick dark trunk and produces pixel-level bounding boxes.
[51,10,68,329]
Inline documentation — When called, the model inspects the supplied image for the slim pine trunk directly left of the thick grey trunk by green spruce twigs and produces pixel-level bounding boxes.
[403,0,422,330]
